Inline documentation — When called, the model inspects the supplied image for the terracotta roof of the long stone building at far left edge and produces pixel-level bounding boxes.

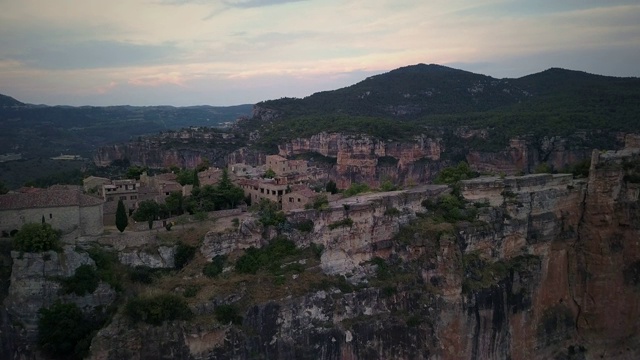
[0,190,103,210]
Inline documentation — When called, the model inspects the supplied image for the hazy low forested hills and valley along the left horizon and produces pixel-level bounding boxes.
[0,100,253,158]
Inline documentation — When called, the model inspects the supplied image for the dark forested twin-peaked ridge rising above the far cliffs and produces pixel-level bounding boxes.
[240,64,640,149]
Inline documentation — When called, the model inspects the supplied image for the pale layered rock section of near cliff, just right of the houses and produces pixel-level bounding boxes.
[289,185,448,281]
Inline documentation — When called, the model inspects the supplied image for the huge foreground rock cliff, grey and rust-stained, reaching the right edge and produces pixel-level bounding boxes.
[89,149,640,359]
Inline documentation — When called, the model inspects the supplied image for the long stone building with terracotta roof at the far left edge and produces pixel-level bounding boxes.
[0,189,104,236]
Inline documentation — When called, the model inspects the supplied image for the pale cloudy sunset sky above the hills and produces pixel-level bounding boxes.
[0,0,640,106]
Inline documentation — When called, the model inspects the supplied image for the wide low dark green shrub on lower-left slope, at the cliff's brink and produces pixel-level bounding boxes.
[124,294,193,325]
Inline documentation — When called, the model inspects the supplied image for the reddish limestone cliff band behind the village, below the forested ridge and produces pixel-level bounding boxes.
[279,128,608,188]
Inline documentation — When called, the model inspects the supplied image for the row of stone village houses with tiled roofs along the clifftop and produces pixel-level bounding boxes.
[0,155,336,237]
